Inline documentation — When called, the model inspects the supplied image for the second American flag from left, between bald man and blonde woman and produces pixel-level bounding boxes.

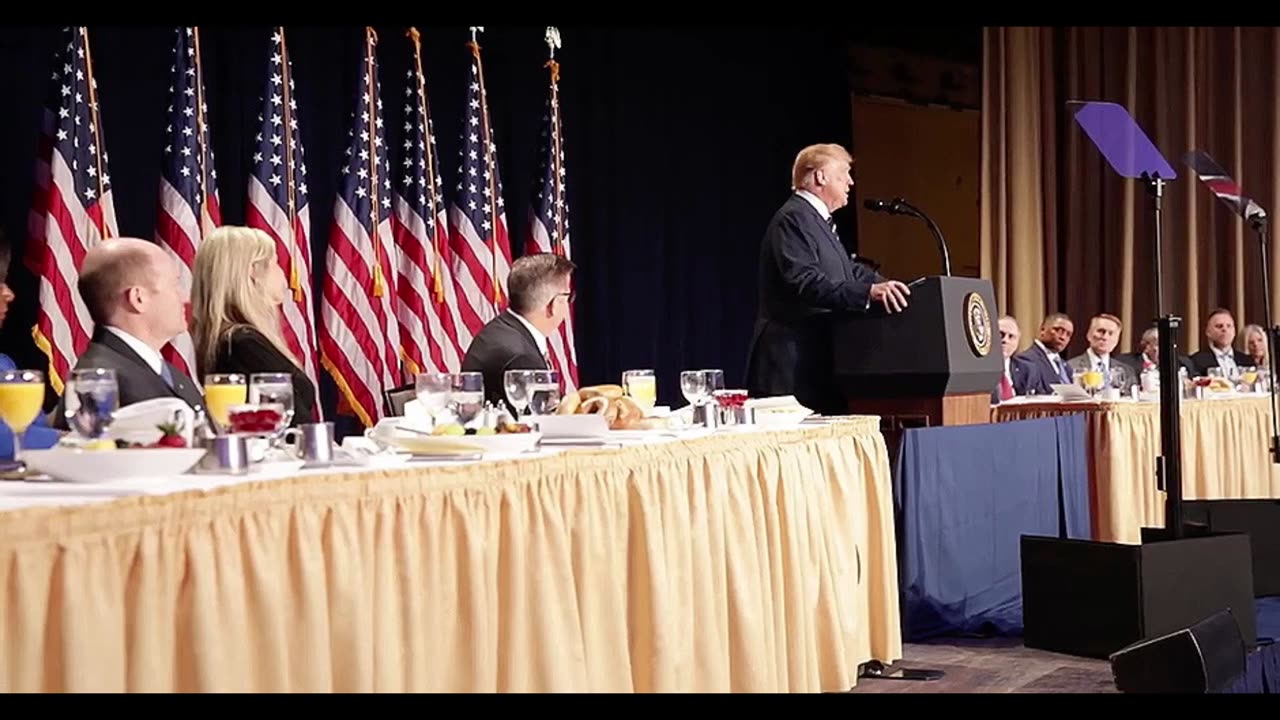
[156,27,223,378]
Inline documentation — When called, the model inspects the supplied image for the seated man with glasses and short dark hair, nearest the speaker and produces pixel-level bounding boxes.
[462,252,575,414]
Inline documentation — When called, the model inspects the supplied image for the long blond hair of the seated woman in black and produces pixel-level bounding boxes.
[191,225,298,372]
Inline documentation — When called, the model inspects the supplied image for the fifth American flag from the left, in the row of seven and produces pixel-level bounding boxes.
[392,28,471,374]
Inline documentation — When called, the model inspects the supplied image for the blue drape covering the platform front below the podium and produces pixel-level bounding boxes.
[893,415,1089,641]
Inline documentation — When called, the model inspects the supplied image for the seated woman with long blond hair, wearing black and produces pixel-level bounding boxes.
[191,225,316,425]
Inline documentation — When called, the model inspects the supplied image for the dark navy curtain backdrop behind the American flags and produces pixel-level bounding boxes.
[0,25,856,411]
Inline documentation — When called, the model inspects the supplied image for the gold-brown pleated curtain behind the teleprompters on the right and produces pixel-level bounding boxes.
[980,27,1280,354]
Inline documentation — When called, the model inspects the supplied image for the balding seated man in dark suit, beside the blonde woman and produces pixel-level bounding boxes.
[52,237,204,429]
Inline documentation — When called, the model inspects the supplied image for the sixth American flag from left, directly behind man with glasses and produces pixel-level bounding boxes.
[449,40,511,347]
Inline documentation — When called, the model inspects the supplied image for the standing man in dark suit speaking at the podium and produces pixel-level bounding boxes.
[746,145,911,415]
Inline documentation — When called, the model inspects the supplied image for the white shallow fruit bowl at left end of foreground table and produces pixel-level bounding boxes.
[22,447,206,483]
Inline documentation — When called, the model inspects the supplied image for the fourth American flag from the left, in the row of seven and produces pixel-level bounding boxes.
[320,28,403,427]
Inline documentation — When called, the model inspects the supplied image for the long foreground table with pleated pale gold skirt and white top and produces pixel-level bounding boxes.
[0,418,901,692]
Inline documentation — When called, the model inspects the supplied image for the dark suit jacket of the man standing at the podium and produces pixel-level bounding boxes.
[746,195,883,414]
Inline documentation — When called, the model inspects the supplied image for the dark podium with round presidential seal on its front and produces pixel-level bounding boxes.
[832,275,1005,448]
